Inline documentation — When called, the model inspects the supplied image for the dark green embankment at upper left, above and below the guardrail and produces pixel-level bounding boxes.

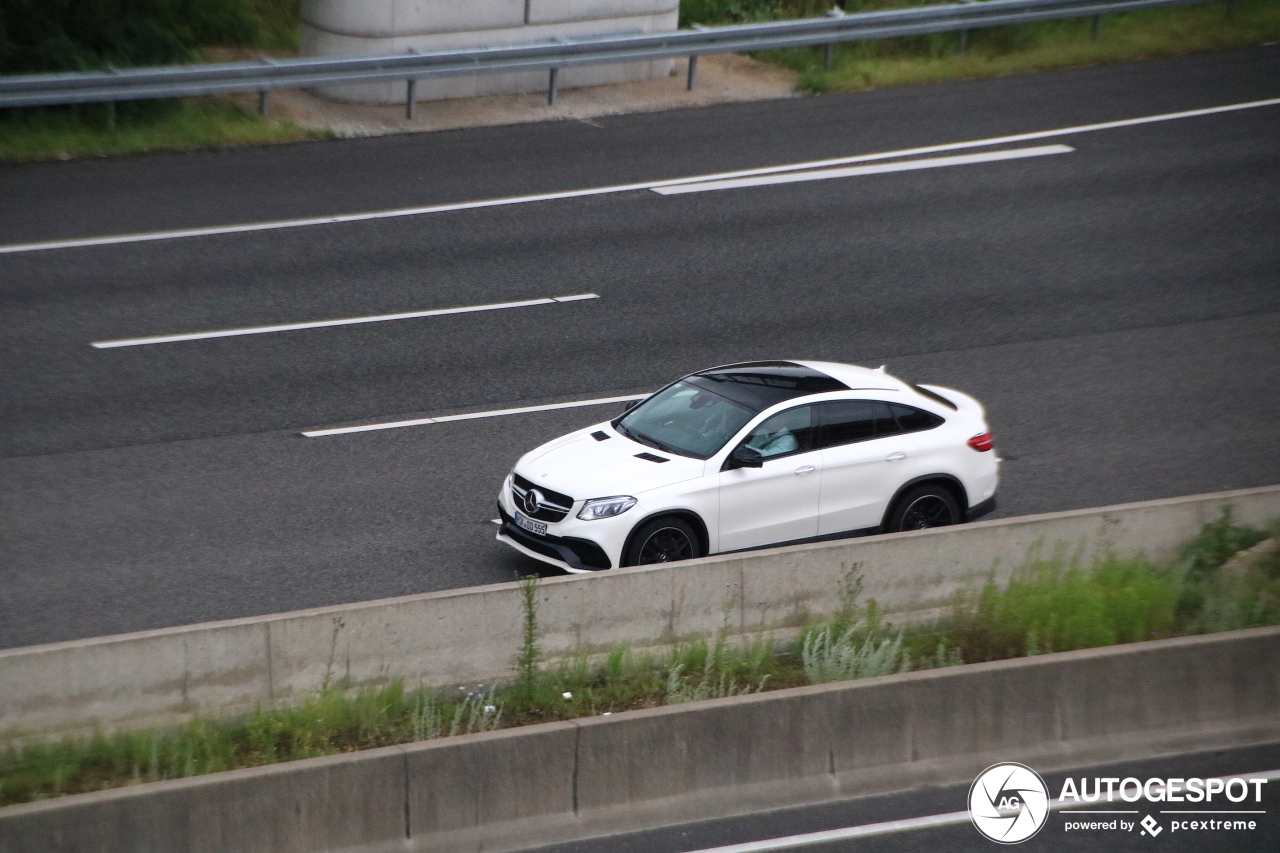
[0,0,329,160]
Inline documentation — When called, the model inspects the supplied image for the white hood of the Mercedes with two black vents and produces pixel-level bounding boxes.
[516,423,707,501]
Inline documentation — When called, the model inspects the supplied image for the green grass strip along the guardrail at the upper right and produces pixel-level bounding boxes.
[755,0,1280,93]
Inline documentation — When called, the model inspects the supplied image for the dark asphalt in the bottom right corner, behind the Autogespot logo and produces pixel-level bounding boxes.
[519,744,1280,853]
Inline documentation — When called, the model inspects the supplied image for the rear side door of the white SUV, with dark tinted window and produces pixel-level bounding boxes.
[818,400,916,535]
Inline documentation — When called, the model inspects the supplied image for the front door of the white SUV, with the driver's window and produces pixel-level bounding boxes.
[719,405,822,551]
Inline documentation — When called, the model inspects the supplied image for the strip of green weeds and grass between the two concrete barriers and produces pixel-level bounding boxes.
[0,515,1280,806]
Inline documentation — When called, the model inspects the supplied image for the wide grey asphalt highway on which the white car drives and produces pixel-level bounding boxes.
[0,47,1280,647]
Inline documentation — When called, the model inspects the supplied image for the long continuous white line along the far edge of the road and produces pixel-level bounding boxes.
[0,97,1280,255]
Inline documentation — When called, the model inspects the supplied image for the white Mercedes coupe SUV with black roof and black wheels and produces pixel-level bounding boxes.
[498,361,1000,573]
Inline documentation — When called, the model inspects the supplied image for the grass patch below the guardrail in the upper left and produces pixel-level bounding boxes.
[0,99,332,160]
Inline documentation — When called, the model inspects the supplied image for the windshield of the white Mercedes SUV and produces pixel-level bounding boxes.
[614,379,755,459]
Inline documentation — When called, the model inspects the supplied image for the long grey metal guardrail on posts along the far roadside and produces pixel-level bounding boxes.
[0,0,1230,118]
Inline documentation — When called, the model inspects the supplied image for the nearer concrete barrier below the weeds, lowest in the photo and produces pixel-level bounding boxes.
[0,628,1280,853]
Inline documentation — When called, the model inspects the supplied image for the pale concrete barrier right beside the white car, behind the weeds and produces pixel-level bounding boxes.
[0,487,1280,744]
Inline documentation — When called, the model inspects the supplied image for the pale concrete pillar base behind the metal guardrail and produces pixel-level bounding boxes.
[300,0,680,104]
